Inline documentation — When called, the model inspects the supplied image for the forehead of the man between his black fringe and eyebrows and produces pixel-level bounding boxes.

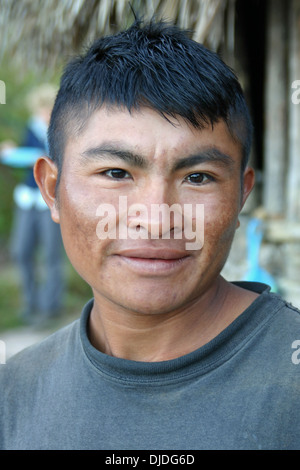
[65,106,240,162]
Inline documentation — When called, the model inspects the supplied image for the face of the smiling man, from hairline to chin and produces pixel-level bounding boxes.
[48,108,253,314]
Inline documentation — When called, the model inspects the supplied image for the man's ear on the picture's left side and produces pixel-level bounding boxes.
[34,157,59,223]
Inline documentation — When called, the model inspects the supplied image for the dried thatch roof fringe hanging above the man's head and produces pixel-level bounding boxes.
[0,0,234,70]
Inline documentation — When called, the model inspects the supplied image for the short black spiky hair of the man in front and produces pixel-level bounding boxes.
[48,19,252,183]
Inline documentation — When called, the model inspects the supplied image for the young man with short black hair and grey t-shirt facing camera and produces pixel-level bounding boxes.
[0,21,300,449]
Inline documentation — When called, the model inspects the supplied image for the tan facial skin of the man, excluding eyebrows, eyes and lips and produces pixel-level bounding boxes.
[36,108,254,362]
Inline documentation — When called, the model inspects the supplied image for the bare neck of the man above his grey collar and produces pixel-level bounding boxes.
[89,277,257,362]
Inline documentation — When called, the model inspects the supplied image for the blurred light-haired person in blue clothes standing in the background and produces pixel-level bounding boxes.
[0,84,63,323]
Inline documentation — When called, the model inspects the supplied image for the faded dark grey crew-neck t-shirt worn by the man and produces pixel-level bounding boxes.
[0,283,300,450]
